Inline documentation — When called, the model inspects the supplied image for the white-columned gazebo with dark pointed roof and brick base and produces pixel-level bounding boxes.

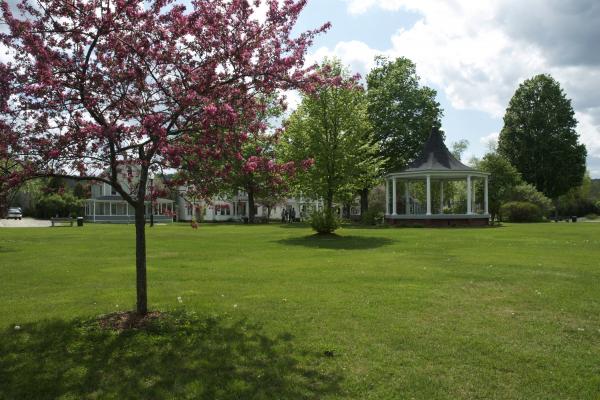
[385,128,490,226]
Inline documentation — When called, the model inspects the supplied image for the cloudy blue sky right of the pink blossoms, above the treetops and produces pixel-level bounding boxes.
[286,0,600,178]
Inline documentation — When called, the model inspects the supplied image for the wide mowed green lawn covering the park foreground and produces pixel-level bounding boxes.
[0,223,600,399]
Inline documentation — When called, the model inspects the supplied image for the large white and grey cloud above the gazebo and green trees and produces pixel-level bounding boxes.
[333,0,600,157]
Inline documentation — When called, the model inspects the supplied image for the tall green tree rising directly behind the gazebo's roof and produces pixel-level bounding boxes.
[367,57,443,172]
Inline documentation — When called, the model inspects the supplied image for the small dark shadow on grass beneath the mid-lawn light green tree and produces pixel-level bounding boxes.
[277,234,394,250]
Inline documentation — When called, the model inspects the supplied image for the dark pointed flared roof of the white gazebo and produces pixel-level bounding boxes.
[402,128,475,173]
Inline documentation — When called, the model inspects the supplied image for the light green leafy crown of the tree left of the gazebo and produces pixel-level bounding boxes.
[281,60,382,228]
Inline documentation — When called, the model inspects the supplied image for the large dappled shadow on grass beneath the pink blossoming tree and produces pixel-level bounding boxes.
[0,313,340,399]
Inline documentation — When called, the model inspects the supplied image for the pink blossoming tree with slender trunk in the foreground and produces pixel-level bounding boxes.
[0,0,327,314]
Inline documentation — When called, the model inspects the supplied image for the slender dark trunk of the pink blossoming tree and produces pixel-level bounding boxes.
[135,203,148,315]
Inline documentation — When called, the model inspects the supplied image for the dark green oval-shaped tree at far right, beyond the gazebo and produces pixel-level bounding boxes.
[498,75,587,199]
